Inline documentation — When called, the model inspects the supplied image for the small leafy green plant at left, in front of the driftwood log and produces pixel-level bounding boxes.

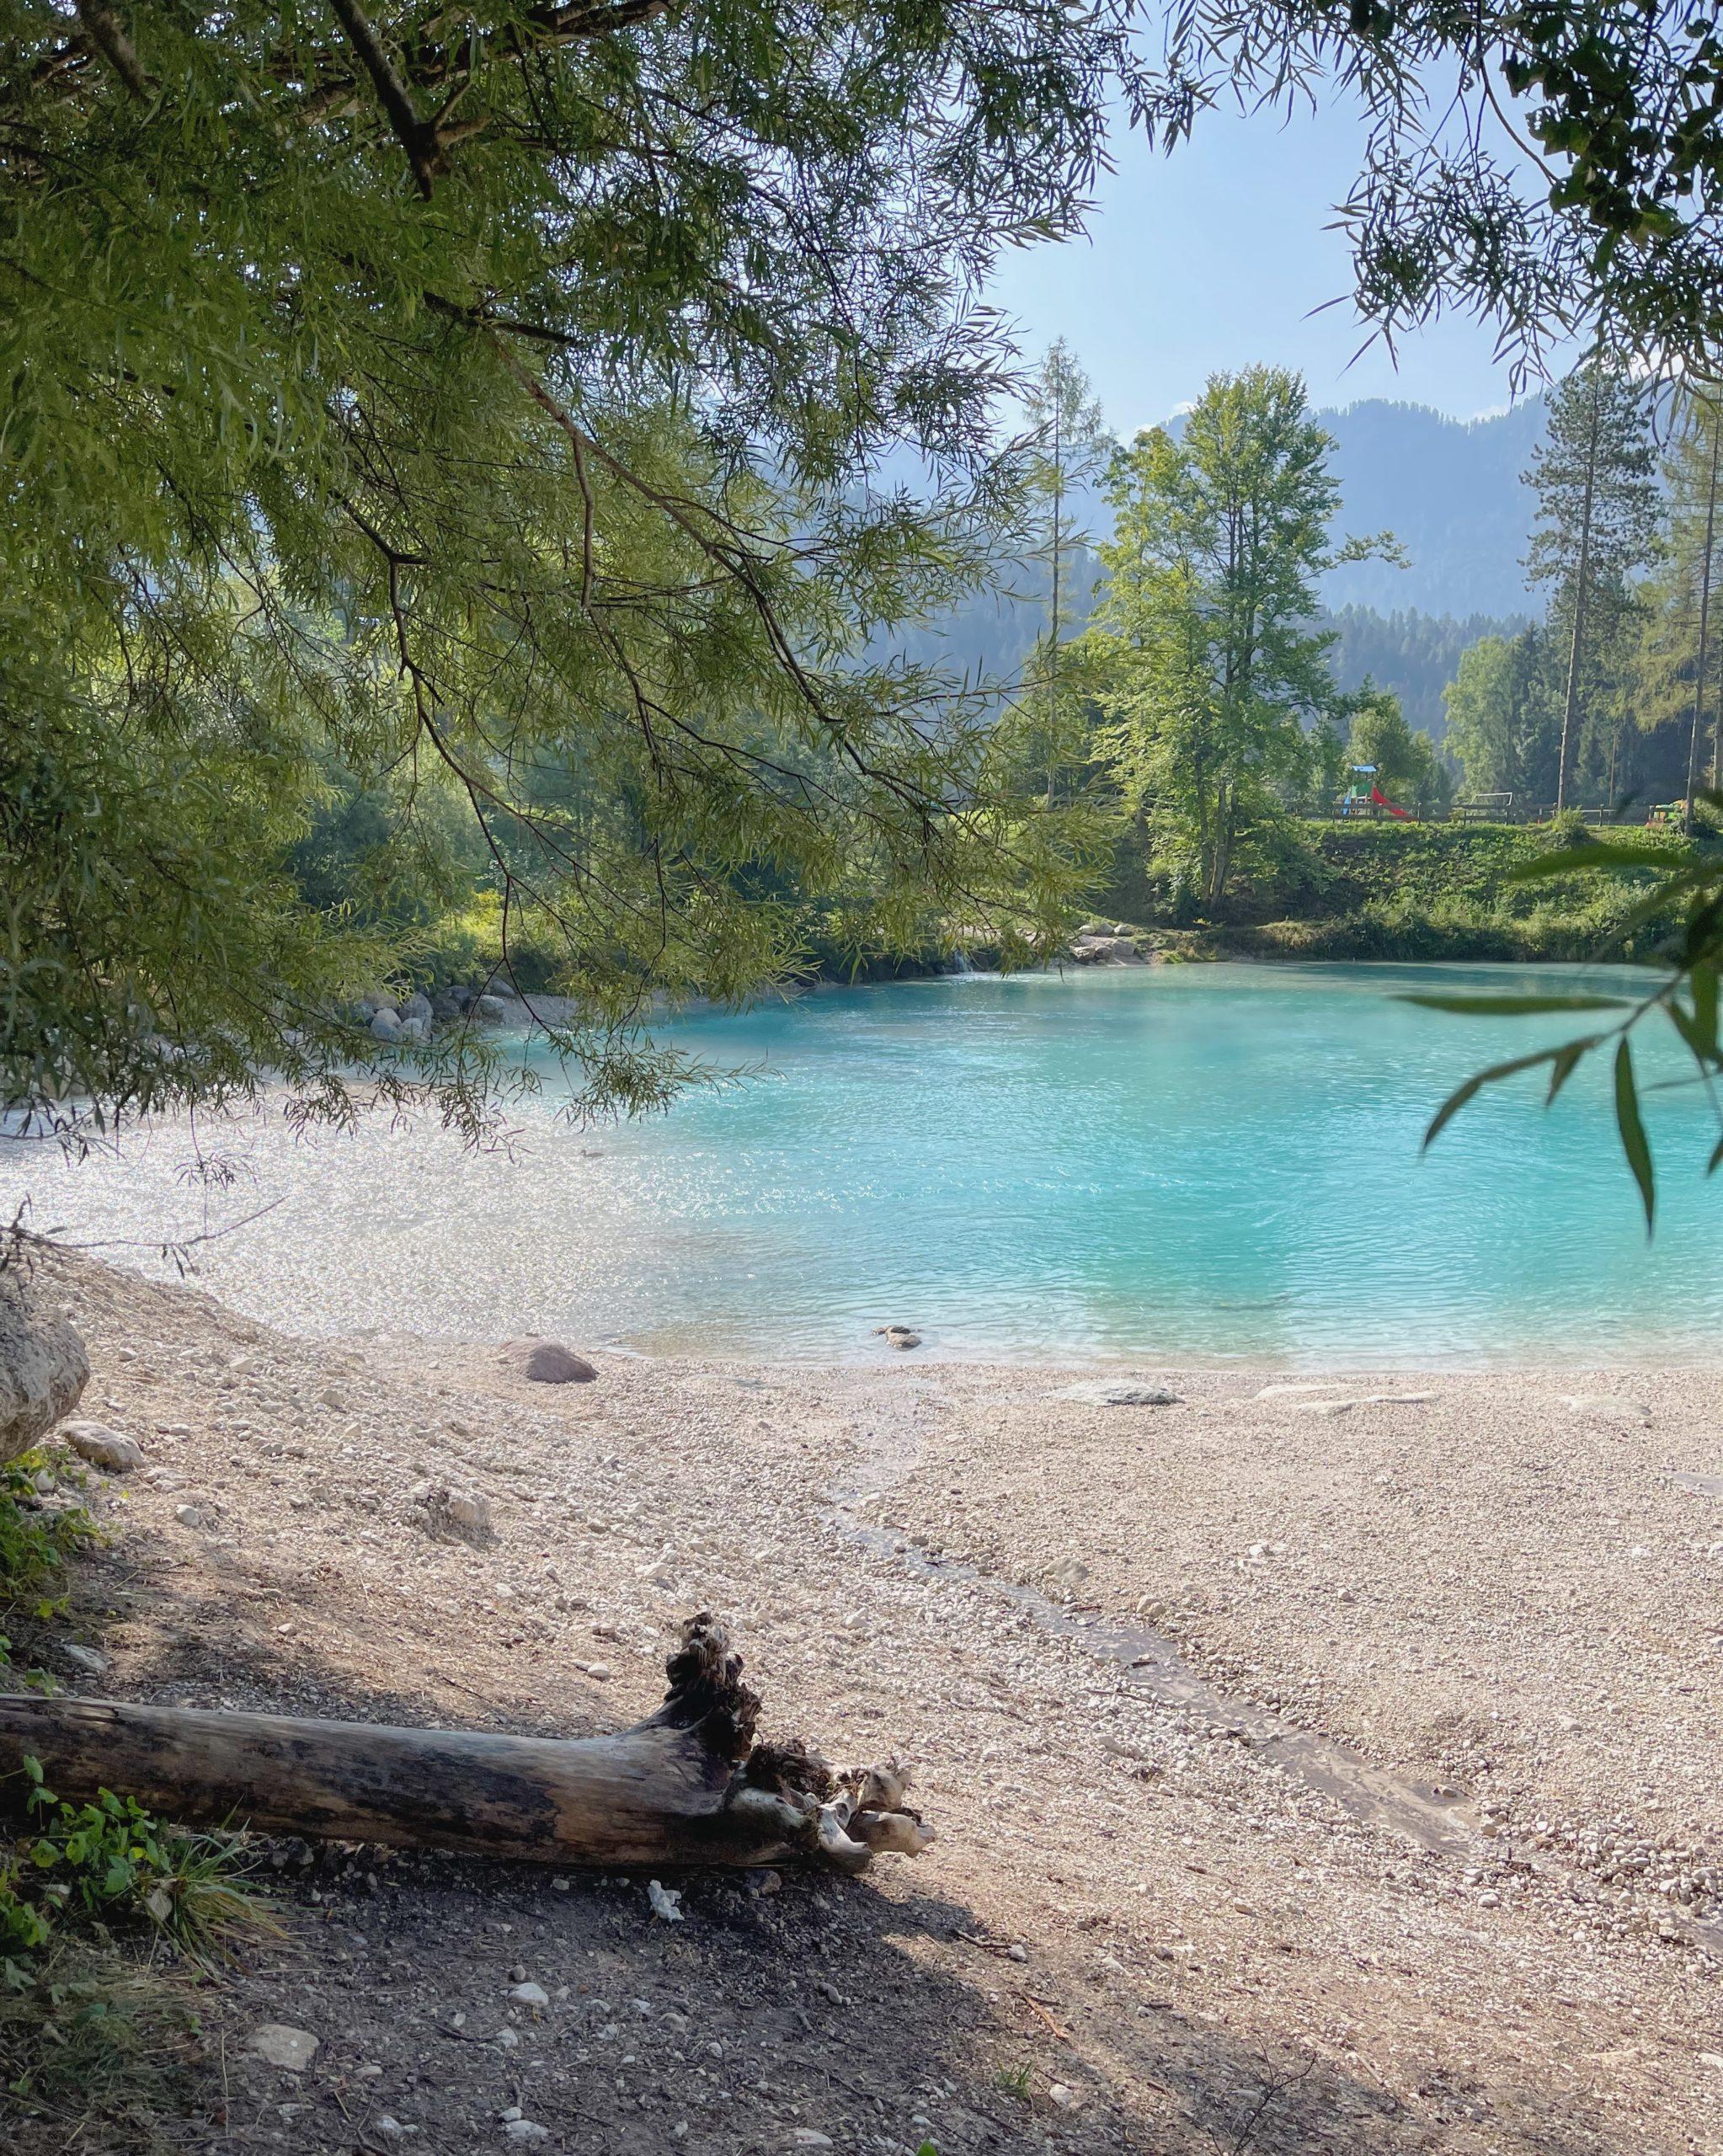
[0,1759,274,1990]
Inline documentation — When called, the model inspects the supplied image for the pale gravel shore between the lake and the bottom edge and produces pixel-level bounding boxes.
[7,1263,1723,2156]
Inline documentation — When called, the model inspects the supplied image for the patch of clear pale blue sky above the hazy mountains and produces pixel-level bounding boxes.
[990,98,1560,435]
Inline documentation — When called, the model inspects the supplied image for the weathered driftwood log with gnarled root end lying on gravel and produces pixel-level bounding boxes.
[0,1613,934,1871]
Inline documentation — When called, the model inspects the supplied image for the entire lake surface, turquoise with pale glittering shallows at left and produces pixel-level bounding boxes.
[0,966,1723,1367]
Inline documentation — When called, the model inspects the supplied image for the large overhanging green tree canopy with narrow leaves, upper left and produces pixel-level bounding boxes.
[0,0,1117,1119]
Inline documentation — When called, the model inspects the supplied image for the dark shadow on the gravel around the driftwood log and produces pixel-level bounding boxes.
[24,1574,1661,2156]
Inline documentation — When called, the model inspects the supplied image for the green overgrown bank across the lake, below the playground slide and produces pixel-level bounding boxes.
[1100,824,1715,959]
